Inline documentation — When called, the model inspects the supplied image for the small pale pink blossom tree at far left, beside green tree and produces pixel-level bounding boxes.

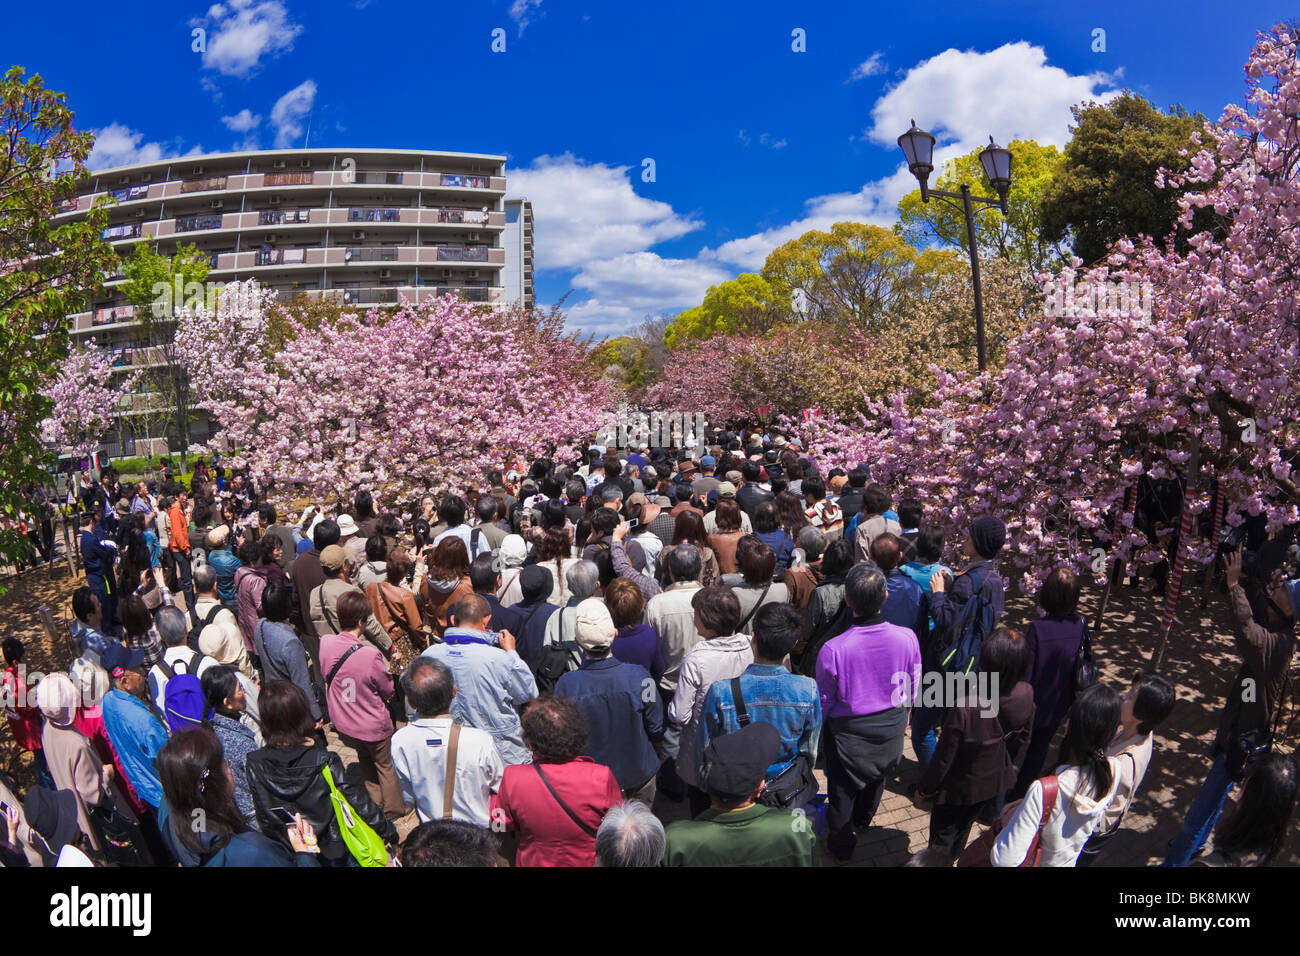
[40,339,140,458]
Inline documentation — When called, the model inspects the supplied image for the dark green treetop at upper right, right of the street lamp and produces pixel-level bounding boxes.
[1041,91,1210,264]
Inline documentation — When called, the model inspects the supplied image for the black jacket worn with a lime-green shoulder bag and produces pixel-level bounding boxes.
[244,744,398,865]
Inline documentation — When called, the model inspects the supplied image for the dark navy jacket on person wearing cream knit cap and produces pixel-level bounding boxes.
[555,657,663,790]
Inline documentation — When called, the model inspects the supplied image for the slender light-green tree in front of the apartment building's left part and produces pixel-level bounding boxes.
[122,242,211,471]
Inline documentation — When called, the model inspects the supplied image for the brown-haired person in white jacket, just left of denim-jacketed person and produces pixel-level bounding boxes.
[668,585,754,816]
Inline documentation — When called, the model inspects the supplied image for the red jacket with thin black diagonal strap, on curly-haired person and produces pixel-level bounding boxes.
[490,757,623,866]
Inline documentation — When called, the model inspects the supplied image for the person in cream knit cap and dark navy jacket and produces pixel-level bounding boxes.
[555,597,663,805]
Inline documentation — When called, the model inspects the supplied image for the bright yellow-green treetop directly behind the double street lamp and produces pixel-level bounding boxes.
[896,139,1062,272]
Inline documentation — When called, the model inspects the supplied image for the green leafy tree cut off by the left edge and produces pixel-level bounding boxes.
[0,66,114,561]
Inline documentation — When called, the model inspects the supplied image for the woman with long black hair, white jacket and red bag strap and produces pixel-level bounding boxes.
[989,684,1123,866]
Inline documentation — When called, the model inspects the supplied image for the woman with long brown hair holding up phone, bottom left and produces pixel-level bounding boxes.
[155,727,320,866]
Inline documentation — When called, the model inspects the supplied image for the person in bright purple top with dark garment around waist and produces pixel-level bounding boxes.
[816,564,920,862]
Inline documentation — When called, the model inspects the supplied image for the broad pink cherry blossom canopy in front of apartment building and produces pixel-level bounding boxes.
[178,286,610,505]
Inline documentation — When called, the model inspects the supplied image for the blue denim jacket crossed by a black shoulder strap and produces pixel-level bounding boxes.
[696,663,822,780]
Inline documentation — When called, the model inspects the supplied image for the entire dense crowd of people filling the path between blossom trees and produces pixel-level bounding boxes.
[0,432,1300,866]
